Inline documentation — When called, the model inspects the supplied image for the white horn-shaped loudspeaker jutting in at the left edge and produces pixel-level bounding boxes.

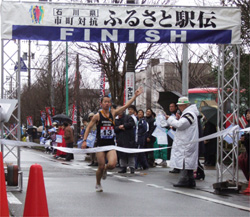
[0,99,17,122]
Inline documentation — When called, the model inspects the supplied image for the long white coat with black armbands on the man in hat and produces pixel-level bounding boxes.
[167,104,199,170]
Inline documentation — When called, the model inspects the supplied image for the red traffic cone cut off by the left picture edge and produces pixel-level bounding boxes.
[0,152,10,217]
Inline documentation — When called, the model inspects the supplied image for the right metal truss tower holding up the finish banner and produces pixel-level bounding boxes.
[214,45,240,191]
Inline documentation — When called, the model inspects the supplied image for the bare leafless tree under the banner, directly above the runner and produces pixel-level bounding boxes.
[73,43,164,104]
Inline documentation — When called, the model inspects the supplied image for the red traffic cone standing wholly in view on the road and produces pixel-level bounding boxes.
[23,164,49,217]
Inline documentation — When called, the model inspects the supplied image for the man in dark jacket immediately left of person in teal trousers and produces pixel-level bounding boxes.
[146,108,156,167]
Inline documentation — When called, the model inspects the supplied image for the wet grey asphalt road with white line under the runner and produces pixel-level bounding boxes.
[3,148,250,217]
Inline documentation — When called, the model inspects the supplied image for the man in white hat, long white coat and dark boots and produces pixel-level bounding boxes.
[166,97,199,188]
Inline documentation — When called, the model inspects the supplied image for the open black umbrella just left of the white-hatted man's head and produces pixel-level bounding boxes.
[157,91,181,114]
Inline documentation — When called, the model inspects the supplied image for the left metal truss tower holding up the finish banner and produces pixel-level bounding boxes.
[1,40,22,191]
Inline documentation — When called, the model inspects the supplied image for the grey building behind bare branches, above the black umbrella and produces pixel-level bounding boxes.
[135,59,213,113]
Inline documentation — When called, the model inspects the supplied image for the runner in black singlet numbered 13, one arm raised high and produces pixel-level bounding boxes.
[82,87,143,192]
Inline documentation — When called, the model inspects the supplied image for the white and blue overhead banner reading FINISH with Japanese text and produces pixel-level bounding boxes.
[1,1,241,44]
